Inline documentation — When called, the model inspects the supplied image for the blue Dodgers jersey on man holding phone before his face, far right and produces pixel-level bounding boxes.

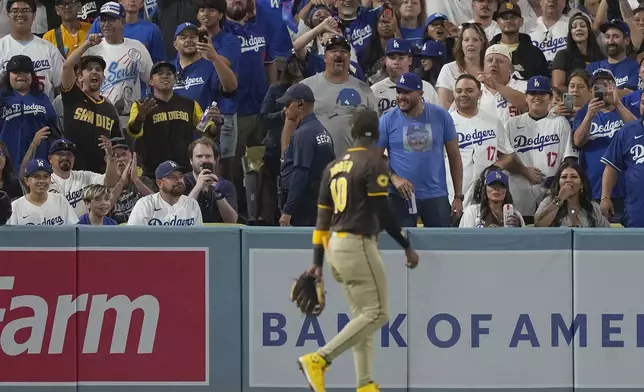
[573,104,624,200]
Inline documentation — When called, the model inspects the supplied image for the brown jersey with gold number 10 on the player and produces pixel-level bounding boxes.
[318,147,389,235]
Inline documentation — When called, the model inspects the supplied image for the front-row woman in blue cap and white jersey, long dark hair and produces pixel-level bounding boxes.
[459,169,525,228]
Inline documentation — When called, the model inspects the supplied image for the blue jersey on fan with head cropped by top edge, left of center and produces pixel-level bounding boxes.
[255,0,293,58]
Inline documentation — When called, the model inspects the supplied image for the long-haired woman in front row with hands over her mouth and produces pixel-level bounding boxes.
[534,161,610,227]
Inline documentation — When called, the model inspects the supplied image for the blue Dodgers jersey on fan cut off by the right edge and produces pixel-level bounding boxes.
[602,120,644,227]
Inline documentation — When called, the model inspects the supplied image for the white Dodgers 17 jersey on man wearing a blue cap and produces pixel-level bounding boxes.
[507,113,577,216]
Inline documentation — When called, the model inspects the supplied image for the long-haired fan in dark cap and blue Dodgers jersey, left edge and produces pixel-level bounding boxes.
[0,55,61,174]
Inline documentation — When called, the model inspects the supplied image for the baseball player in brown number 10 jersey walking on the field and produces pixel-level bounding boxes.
[298,109,418,392]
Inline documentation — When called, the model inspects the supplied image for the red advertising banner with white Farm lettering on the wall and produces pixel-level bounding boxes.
[0,248,209,385]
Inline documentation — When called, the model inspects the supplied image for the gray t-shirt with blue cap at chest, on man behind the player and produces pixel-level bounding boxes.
[302,72,378,157]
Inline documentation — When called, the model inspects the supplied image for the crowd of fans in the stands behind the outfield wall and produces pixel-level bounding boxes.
[0,0,644,227]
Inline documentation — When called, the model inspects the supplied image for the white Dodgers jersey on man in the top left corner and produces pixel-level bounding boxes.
[0,35,65,100]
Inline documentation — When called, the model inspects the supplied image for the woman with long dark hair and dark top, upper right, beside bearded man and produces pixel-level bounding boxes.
[552,13,606,92]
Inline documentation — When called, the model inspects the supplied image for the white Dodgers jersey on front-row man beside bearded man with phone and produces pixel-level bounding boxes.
[127,192,203,226]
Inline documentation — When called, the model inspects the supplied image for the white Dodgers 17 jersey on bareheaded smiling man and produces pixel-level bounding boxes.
[445,110,513,207]
